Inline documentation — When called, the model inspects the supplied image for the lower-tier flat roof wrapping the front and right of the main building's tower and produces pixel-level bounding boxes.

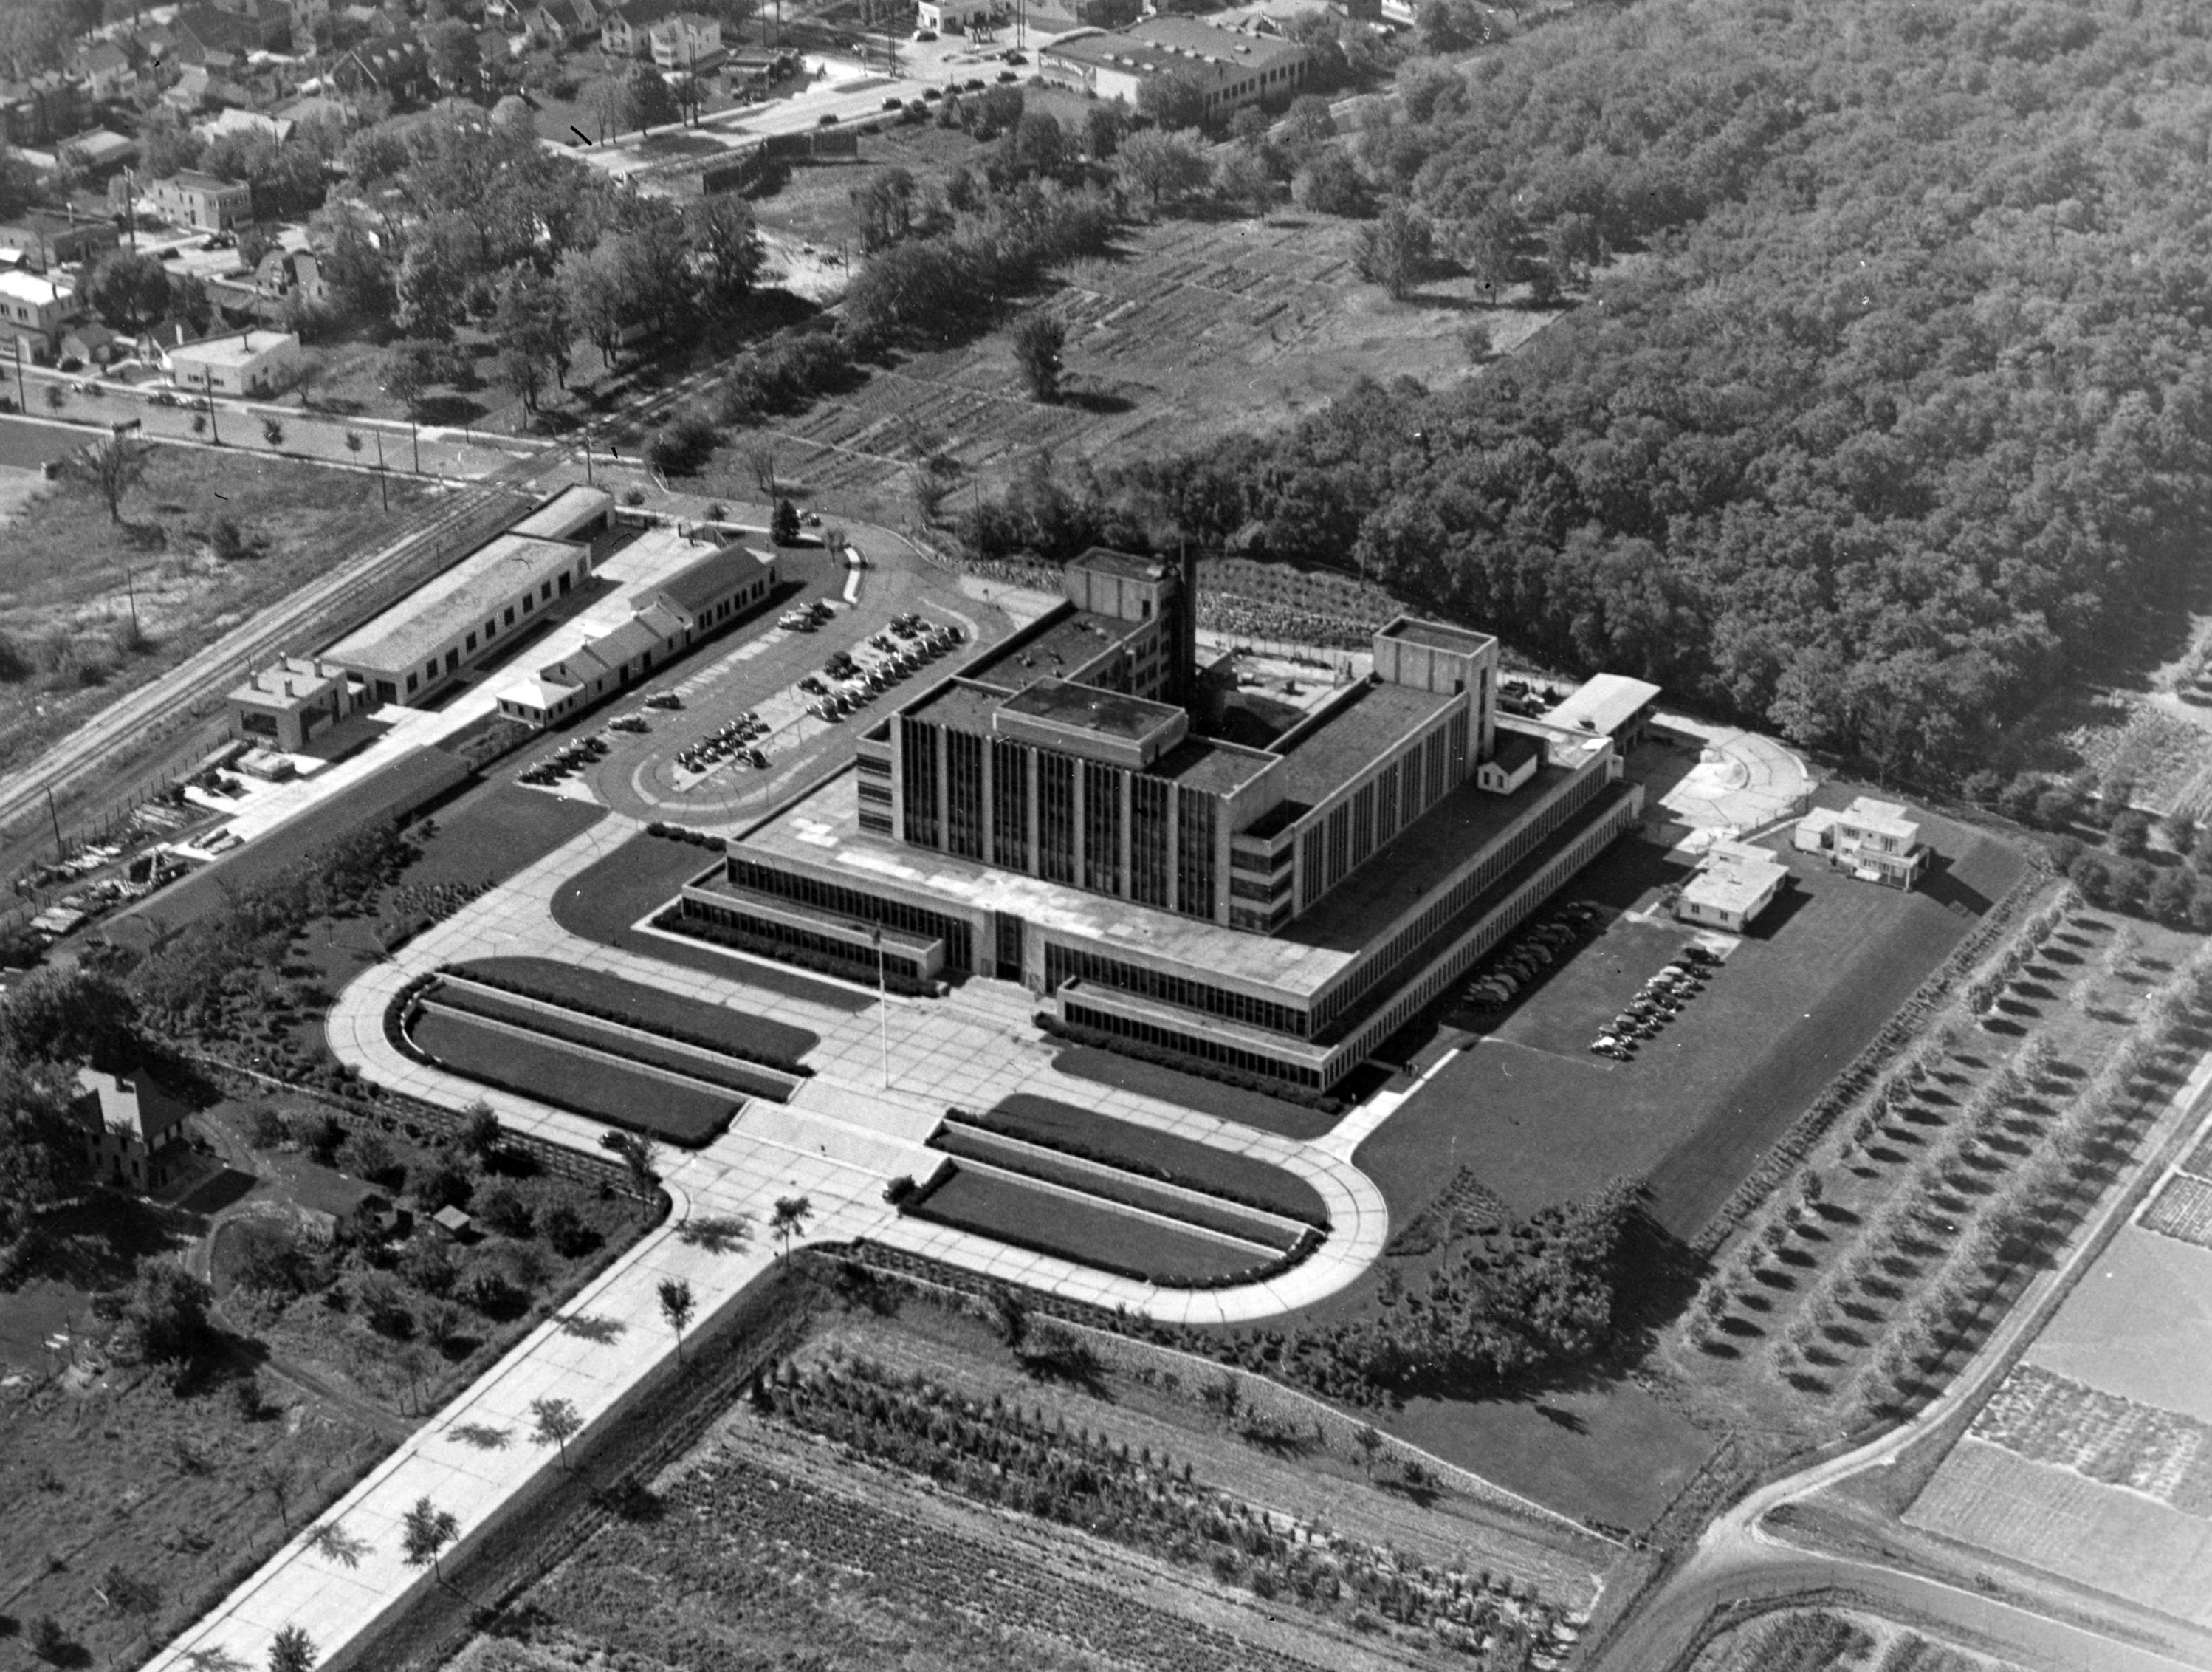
[730,745,1601,1002]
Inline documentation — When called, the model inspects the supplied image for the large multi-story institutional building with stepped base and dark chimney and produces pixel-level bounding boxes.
[681,551,1641,1090]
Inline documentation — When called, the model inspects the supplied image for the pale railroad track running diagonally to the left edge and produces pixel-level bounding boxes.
[0,458,546,836]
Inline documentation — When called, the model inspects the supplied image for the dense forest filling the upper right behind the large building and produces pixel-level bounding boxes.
[971,0,2212,778]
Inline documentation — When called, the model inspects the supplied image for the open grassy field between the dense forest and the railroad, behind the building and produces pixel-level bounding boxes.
[715,210,1546,522]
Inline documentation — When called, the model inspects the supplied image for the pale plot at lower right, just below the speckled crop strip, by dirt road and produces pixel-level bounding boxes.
[1905,1438,2212,1623]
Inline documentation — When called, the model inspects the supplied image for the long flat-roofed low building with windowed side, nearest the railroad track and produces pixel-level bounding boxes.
[323,531,591,705]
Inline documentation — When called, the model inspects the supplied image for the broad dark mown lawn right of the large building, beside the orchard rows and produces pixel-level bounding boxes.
[1354,820,2022,1241]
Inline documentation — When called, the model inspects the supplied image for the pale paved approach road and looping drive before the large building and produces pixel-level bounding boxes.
[151,814,1389,1672]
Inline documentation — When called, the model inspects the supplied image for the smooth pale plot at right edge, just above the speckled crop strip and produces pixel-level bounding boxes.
[2028,1225,2212,1422]
